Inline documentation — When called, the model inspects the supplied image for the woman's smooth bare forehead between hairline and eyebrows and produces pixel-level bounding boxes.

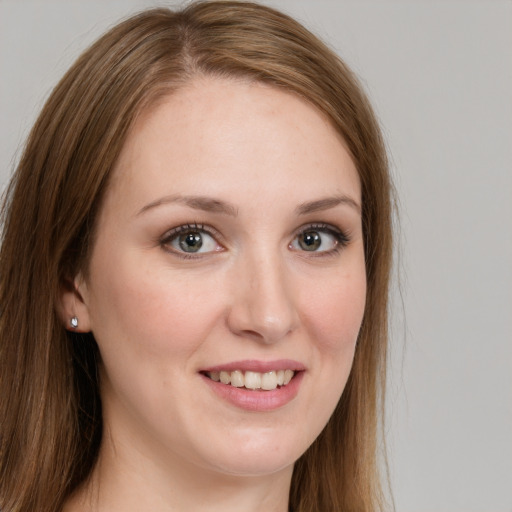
[107,78,360,210]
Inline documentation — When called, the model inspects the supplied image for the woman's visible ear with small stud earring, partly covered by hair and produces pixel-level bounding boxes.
[58,273,91,332]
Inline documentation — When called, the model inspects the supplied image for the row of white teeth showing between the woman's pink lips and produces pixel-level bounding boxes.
[204,370,296,391]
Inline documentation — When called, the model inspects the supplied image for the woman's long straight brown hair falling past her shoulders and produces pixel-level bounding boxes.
[0,1,392,512]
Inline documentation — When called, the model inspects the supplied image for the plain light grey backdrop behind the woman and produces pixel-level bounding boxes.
[0,0,512,512]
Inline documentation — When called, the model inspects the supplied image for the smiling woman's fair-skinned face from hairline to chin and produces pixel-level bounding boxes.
[73,79,366,475]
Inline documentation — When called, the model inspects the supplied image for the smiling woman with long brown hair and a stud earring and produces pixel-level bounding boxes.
[0,2,391,512]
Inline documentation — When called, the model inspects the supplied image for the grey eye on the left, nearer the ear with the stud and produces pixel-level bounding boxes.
[161,224,223,255]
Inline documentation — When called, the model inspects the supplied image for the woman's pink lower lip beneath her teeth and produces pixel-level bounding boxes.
[201,371,304,412]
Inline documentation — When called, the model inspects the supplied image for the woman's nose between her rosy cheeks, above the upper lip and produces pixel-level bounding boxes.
[228,250,299,344]
